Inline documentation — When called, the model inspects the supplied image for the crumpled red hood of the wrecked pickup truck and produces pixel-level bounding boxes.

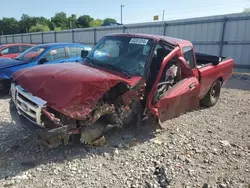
[13,63,141,120]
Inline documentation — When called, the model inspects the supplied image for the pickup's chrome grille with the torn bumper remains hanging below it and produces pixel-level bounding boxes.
[10,83,80,148]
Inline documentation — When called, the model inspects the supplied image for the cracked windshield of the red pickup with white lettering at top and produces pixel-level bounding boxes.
[86,36,154,77]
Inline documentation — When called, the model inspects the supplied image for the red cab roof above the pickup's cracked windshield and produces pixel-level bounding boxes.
[106,33,191,46]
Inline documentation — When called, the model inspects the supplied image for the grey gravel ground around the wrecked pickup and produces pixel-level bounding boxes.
[0,75,250,188]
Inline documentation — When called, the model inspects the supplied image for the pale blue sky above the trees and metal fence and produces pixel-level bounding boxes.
[0,0,250,24]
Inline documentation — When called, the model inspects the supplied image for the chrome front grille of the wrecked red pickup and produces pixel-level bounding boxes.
[10,83,47,127]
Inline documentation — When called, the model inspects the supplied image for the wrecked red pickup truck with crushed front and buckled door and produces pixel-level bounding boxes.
[11,34,234,147]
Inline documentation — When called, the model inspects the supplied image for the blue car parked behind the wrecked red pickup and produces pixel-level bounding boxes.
[0,43,91,94]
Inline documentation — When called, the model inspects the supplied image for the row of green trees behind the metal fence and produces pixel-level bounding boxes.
[0,12,116,35]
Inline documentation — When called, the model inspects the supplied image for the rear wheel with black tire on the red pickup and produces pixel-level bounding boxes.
[201,80,221,107]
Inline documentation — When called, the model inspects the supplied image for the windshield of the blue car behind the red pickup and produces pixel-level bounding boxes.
[15,46,45,61]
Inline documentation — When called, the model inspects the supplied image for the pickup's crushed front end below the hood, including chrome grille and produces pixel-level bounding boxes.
[11,79,145,148]
